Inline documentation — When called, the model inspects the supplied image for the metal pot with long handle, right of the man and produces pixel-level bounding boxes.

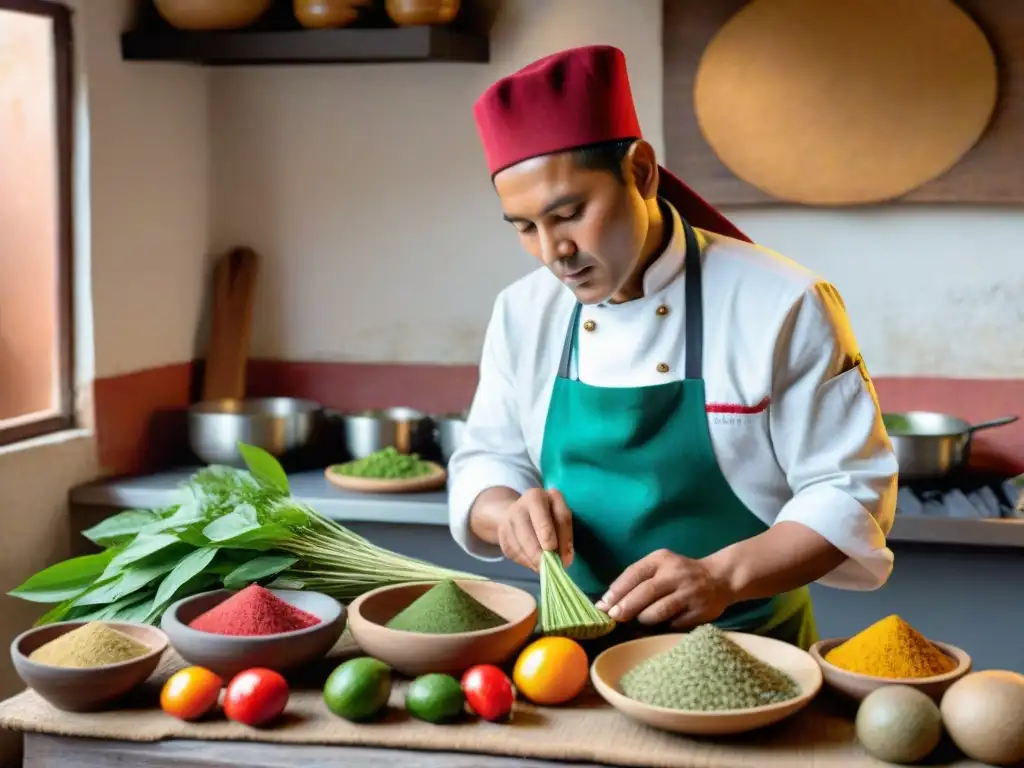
[882,411,1019,480]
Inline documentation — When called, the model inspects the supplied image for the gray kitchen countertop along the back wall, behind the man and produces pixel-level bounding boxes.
[71,468,1024,549]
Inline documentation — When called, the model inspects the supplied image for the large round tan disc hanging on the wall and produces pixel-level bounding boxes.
[693,0,997,206]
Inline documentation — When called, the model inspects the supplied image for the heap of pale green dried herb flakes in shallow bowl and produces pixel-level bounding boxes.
[618,625,800,712]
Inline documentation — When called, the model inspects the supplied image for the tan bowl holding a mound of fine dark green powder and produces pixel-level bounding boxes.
[348,580,537,677]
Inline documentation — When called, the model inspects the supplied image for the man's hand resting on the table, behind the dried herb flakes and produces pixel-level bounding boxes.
[597,549,732,630]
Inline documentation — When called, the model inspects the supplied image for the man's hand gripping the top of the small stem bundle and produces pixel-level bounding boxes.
[498,488,572,570]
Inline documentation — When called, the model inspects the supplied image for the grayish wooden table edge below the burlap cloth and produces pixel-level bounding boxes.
[24,733,607,768]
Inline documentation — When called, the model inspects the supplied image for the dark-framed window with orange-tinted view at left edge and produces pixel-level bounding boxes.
[0,0,75,444]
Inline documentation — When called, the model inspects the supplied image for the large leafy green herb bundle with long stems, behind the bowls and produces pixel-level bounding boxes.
[9,445,481,626]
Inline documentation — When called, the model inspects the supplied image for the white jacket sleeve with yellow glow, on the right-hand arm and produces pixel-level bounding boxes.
[769,283,898,590]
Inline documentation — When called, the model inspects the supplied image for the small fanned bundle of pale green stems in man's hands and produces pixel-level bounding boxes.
[537,552,615,640]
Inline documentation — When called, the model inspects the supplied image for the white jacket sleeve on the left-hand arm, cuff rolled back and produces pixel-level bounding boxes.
[449,295,541,561]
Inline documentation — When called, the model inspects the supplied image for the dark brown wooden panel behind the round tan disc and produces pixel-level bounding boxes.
[663,0,1024,206]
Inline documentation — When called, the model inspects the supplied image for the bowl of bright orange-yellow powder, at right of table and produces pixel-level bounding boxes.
[810,615,971,701]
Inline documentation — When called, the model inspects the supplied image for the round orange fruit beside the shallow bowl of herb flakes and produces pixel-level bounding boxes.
[512,637,590,706]
